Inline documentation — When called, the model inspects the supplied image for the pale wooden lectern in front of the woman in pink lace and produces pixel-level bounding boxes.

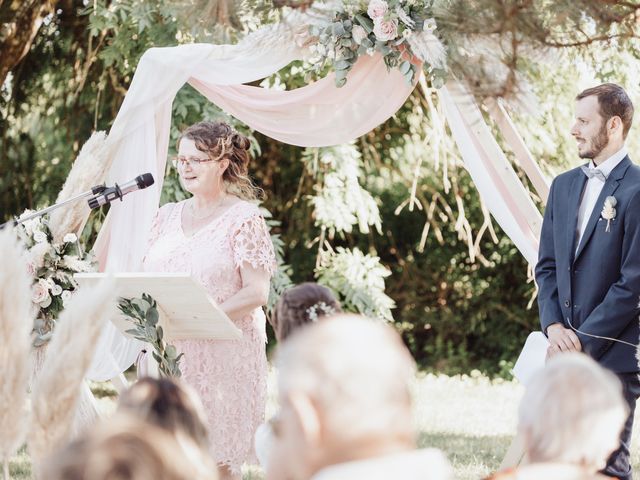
[74,272,242,374]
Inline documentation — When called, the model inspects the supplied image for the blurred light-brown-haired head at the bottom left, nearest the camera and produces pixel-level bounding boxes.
[42,414,218,480]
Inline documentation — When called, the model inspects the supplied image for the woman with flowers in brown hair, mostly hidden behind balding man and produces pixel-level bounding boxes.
[255,282,341,470]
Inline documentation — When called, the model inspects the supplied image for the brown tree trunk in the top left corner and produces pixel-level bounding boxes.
[0,0,57,85]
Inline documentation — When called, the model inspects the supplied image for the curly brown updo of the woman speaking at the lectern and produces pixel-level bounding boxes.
[177,122,264,200]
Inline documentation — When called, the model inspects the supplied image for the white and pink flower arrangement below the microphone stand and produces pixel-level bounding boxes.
[17,210,95,347]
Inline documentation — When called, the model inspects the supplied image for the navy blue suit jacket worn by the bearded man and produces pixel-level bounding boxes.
[535,157,640,373]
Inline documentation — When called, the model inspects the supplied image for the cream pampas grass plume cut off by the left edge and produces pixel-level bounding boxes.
[0,228,34,478]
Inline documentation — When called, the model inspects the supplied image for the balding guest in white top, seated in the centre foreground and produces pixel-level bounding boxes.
[267,315,451,480]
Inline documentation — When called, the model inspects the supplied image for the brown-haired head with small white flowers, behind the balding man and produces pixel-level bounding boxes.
[272,282,341,342]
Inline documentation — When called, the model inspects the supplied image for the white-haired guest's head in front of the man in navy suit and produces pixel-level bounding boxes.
[519,353,628,472]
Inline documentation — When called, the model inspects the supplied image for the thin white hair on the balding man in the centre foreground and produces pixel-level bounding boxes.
[277,315,415,442]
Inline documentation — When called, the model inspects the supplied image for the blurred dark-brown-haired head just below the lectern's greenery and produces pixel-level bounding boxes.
[118,377,208,450]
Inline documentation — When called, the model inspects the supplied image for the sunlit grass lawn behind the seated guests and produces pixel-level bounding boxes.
[10,374,640,480]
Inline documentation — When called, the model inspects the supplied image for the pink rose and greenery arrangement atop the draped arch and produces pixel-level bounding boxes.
[309,0,446,87]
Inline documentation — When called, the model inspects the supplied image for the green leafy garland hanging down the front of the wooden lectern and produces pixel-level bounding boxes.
[118,293,184,377]
